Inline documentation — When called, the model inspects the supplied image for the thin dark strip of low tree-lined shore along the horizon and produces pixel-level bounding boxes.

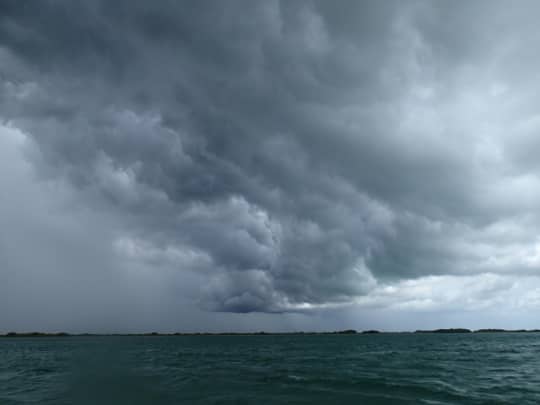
[0,328,540,338]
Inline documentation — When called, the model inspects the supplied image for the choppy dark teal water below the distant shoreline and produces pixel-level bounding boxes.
[0,333,540,405]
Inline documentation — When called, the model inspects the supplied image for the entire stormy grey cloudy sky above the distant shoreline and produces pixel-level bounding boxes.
[0,0,540,332]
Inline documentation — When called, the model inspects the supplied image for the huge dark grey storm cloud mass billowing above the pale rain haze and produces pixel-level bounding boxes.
[0,1,540,322]
